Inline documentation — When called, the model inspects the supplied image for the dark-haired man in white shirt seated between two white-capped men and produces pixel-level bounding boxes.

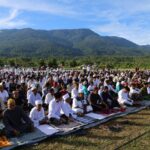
[48,92,69,125]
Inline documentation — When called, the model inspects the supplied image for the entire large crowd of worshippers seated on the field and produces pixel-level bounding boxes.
[0,67,150,137]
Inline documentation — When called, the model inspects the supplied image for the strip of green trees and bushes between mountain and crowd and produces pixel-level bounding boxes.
[0,56,150,69]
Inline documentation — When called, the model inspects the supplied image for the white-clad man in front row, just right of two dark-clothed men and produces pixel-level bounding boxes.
[118,87,133,106]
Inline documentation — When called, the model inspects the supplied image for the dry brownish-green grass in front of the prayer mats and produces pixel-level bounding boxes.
[18,109,150,150]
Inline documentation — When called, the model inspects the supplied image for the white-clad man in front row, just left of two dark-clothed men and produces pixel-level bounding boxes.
[72,90,93,114]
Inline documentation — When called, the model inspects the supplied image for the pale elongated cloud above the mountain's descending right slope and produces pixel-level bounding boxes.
[91,21,150,45]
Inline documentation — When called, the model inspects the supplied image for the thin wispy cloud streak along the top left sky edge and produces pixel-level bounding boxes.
[0,0,78,16]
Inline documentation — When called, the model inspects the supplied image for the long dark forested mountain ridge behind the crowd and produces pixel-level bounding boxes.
[0,28,150,57]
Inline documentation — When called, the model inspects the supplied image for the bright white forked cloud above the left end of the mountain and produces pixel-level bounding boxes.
[0,9,26,28]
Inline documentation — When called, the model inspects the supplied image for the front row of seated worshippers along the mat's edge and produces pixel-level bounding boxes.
[0,86,142,137]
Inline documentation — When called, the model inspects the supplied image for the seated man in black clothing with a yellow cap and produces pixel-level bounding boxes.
[3,99,33,137]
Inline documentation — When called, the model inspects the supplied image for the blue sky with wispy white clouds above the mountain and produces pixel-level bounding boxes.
[0,0,150,45]
